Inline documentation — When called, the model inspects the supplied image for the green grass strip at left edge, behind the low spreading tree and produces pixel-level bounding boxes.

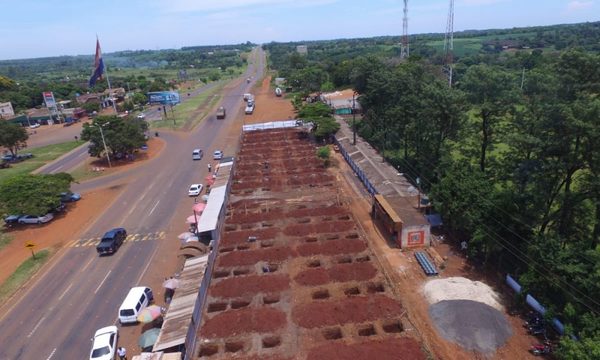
[0,140,84,182]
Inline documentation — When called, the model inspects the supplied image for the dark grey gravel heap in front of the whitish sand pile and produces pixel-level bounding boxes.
[429,300,512,353]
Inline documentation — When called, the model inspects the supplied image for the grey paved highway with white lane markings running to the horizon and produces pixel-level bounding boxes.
[0,51,264,360]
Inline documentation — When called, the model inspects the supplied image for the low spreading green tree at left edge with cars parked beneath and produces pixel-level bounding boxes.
[0,173,73,216]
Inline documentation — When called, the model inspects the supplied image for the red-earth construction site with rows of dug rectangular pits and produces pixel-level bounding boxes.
[196,127,427,359]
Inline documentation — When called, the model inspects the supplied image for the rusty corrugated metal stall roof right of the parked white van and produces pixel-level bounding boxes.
[152,254,208,352]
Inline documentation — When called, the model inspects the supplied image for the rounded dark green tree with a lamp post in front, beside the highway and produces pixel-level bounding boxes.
[81,116,148,157]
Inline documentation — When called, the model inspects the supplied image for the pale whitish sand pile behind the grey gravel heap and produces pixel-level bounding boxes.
[423,277,504,311]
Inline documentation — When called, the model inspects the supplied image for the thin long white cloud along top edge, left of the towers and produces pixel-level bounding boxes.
[165,0,339,12]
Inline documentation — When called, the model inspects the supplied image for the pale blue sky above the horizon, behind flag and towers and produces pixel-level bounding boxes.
[0,0,600,60]
